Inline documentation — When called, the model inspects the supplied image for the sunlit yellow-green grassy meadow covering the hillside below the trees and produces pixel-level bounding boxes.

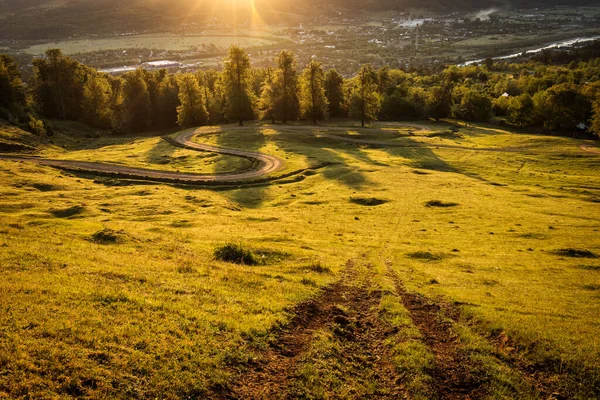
[0,121,600,399]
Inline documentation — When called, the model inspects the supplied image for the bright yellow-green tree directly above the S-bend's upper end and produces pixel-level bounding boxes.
[177,74,208,128]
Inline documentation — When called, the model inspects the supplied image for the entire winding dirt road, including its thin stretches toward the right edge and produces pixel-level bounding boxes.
[0,124,600,184]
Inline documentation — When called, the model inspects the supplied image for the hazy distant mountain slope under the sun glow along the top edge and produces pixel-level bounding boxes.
[0,0,600,39]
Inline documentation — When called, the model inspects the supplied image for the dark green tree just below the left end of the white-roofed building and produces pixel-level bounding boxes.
[122,69,151,132]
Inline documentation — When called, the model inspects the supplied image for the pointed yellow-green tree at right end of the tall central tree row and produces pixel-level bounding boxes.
[350,64,381,127]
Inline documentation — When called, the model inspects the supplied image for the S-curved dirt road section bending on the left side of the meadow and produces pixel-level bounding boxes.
[0,129,283,184]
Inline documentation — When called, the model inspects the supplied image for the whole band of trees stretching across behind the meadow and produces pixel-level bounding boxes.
[0,46,600,135]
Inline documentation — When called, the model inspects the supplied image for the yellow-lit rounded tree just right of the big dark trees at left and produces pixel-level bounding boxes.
[81,74,111,128]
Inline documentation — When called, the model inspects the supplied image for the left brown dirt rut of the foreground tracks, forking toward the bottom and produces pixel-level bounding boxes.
[226,262,405,399]
